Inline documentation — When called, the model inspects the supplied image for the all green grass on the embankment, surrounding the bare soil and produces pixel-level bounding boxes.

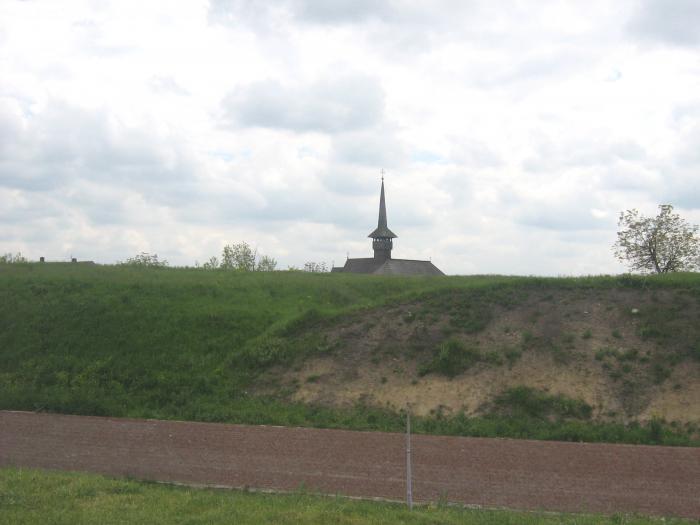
[0,264,700,445]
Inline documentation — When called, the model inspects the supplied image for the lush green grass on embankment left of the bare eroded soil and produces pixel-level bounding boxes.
[0,264,464,418]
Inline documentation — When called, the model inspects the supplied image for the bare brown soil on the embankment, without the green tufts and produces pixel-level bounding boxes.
[260,290,700,424]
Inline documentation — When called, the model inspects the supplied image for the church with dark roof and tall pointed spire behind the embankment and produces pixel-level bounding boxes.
[331,177,445,275]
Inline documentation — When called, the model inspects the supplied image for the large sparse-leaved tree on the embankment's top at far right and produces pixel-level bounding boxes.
[613,204,700,273]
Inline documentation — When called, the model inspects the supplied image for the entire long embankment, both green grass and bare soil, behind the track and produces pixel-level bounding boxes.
[0,264,700,445]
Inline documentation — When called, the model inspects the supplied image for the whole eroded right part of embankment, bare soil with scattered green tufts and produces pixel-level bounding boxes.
[260,289,700,423]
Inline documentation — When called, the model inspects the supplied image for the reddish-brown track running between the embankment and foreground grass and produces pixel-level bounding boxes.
[0,411,700,519]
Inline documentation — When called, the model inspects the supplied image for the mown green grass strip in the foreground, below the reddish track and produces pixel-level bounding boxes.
[0,468,697,525]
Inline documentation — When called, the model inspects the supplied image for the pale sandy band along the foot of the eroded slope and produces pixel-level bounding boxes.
[292,353,700,423]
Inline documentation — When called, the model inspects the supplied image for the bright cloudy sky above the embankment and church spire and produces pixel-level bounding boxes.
[0,0,700,275]
